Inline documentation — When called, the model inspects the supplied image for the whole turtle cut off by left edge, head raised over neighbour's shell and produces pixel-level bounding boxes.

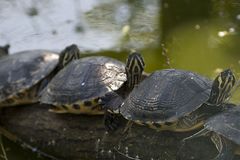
[0,44,80,108]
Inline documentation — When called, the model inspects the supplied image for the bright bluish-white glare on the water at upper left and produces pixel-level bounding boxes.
[0,0,120,52]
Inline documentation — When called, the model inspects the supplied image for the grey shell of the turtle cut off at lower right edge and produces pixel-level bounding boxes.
[204,106,240,145]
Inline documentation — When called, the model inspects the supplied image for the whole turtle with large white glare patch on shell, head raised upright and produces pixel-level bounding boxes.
[40,51,144,115]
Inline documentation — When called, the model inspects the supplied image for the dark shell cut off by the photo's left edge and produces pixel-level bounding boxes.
[0,50,59,102]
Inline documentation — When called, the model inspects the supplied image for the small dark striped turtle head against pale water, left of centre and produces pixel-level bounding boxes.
[58,44,80,69]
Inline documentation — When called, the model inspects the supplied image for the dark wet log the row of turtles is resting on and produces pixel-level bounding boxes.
[0,104,218,160]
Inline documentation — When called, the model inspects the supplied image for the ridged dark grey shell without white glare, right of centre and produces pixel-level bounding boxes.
[120,69,212,123]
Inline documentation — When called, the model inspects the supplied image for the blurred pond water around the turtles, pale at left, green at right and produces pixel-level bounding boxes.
[0,0,240,160]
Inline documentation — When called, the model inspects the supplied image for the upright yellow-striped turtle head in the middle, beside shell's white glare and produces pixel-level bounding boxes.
[125,51,145,88]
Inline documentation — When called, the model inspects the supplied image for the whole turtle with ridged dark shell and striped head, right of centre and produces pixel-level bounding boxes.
[104,69,235,132]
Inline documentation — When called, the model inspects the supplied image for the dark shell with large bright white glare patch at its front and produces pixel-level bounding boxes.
[41,56,126,105]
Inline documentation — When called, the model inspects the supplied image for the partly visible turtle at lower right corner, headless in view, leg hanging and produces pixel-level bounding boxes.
[183,104,240,160]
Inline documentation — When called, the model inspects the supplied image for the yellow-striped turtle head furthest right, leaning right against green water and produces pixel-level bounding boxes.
[208,69,235,105]
